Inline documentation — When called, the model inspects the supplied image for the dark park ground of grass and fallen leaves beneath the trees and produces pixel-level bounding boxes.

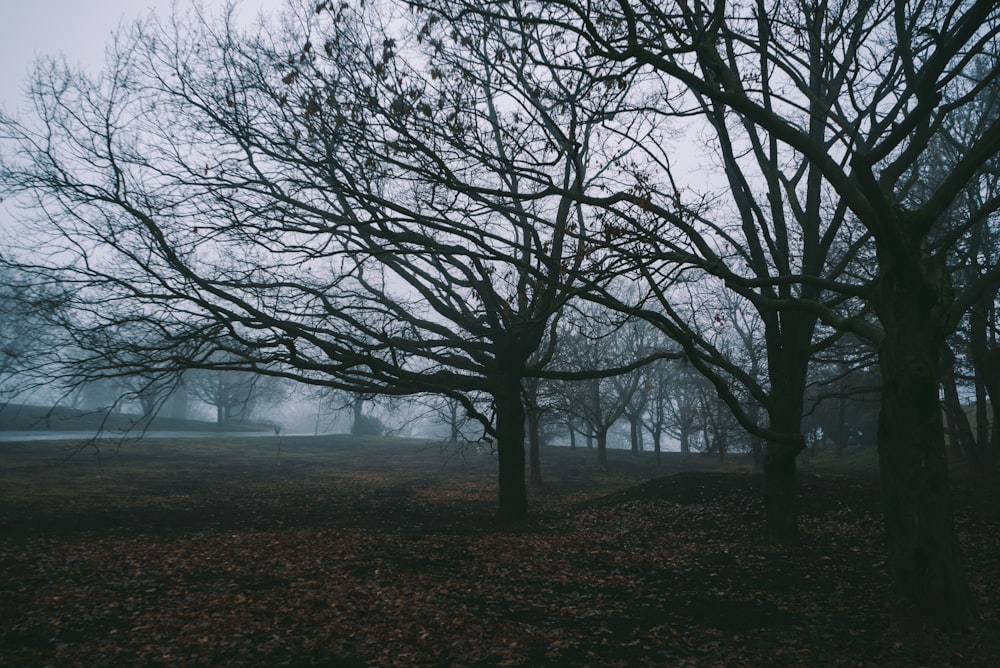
[0,437,1000,666]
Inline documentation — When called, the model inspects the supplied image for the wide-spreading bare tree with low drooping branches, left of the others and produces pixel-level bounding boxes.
[0,2,648,517]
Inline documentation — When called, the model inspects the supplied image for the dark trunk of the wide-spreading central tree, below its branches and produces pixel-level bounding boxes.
[493,380,528,520]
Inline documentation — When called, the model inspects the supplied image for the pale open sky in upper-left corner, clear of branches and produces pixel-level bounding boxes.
[0,0,284,113]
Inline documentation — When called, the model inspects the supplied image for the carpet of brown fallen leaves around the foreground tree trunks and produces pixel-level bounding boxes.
[0,448,1000,666]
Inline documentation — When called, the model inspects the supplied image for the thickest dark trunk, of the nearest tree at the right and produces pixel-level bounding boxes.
[876,249,976,627]
